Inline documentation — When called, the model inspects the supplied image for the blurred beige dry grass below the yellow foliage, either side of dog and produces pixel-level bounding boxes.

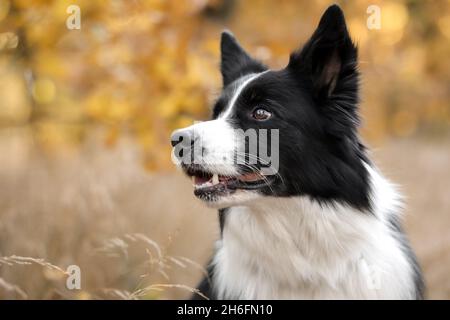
[0,131,450,299]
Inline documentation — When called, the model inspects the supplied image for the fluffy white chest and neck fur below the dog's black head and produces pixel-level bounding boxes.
[213,165,415,299]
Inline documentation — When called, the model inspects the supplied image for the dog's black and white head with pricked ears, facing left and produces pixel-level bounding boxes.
[172,5,369,208]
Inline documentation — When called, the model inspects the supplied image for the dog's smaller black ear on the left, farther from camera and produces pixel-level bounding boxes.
[220,31,267,87]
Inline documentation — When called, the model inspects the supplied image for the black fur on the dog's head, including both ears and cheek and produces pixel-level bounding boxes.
[213,6,370,211]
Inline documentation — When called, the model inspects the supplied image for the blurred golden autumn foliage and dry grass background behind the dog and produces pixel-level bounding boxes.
[0,0,450,299]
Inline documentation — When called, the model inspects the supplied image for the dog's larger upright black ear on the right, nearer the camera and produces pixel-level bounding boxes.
[288,5,358,98]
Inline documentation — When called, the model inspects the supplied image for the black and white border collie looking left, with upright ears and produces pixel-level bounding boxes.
[172,5,423,299]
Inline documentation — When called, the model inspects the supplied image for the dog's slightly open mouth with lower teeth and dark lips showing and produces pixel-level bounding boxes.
[184,165,271,201]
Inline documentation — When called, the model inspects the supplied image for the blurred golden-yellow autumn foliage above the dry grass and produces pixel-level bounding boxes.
[0,0,450,169]
